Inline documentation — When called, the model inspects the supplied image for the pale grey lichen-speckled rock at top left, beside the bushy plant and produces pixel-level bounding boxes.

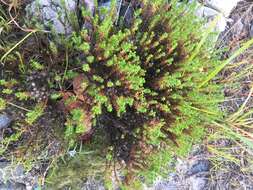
[26,0,77,34]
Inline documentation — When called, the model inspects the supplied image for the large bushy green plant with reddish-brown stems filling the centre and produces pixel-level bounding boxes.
[59,0,223,183]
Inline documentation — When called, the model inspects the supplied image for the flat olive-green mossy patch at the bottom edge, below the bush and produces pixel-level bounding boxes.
[47,150,105,190]
